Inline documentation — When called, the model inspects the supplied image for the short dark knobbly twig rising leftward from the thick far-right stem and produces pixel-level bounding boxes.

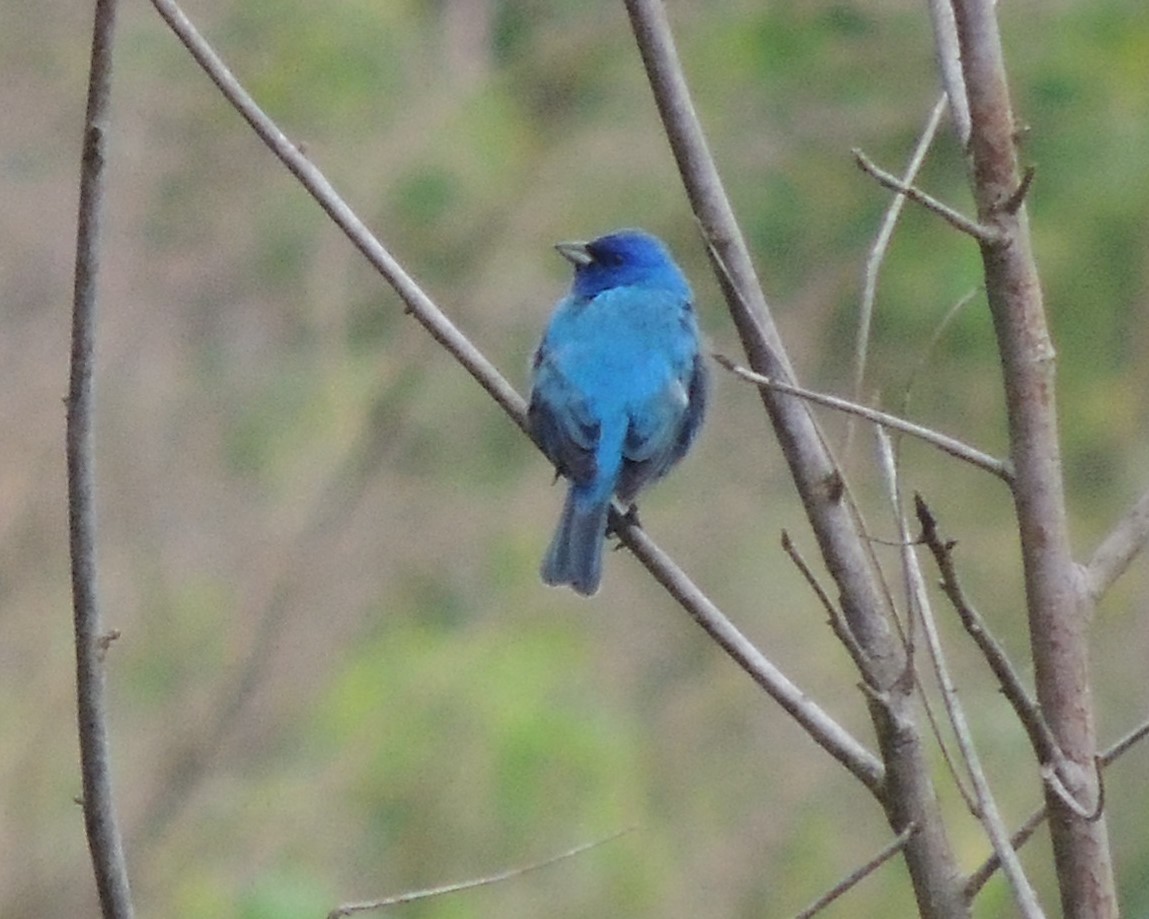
[913,494,1062,764]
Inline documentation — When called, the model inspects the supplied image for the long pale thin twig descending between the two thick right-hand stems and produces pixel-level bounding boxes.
[877,427,1044,919]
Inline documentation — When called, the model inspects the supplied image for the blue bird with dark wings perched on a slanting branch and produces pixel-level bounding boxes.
[527,230,707,596]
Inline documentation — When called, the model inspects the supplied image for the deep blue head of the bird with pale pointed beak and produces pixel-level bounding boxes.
[555,230,691,299]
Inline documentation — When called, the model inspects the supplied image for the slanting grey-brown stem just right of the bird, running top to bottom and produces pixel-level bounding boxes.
[625,0,969,917]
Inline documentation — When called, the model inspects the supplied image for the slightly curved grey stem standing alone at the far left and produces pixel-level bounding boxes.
[67,0,132,919]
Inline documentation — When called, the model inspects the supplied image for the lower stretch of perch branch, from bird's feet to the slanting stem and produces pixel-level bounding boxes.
[610,509,885,795]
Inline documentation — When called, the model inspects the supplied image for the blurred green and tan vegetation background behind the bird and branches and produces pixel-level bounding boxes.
[0,0,1149,919]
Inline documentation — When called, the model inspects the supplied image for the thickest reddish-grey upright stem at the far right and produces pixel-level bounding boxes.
[954,0,1117,917]
